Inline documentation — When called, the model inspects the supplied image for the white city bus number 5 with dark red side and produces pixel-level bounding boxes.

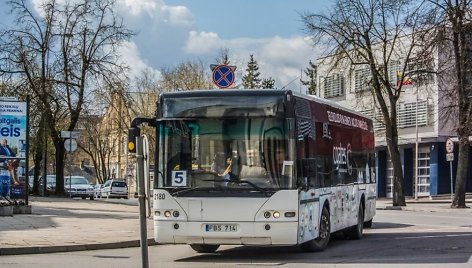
[149,90,377,253]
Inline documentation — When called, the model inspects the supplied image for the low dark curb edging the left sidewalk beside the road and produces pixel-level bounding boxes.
[0,238,157,256]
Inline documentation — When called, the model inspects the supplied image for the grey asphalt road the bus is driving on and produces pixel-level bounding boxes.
[0,203,472,268]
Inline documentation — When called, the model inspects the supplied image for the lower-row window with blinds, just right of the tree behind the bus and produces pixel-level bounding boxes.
[397,100,428,128]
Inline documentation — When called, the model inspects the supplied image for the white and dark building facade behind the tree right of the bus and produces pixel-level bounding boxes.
[317,42,472,197]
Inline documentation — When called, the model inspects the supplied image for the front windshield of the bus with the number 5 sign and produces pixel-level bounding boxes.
[156,117,295,193]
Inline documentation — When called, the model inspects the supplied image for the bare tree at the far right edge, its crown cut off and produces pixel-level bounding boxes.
[429,0,472,208]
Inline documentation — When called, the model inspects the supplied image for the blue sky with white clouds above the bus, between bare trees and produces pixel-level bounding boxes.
[0,0,330,89]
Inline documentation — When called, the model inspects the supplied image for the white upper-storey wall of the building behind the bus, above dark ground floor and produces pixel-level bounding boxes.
[317,42,455,146]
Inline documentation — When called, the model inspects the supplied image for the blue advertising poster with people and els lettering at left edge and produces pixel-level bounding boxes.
[0,101,27,198]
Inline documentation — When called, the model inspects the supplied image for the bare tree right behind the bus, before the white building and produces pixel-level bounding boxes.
[302,0,436,206]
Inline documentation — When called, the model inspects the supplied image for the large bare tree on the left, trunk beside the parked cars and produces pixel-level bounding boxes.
[1,0,132,194]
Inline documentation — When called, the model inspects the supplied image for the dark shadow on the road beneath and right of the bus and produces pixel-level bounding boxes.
[176,230,472,265]
